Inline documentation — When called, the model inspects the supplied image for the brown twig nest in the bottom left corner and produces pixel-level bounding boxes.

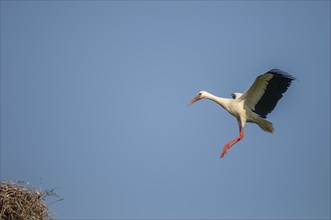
[0,182,57,220]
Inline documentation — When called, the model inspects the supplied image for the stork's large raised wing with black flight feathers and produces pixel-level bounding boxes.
[240,69,295,118]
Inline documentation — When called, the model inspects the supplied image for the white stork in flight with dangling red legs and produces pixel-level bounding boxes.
[188,69,295,158]
